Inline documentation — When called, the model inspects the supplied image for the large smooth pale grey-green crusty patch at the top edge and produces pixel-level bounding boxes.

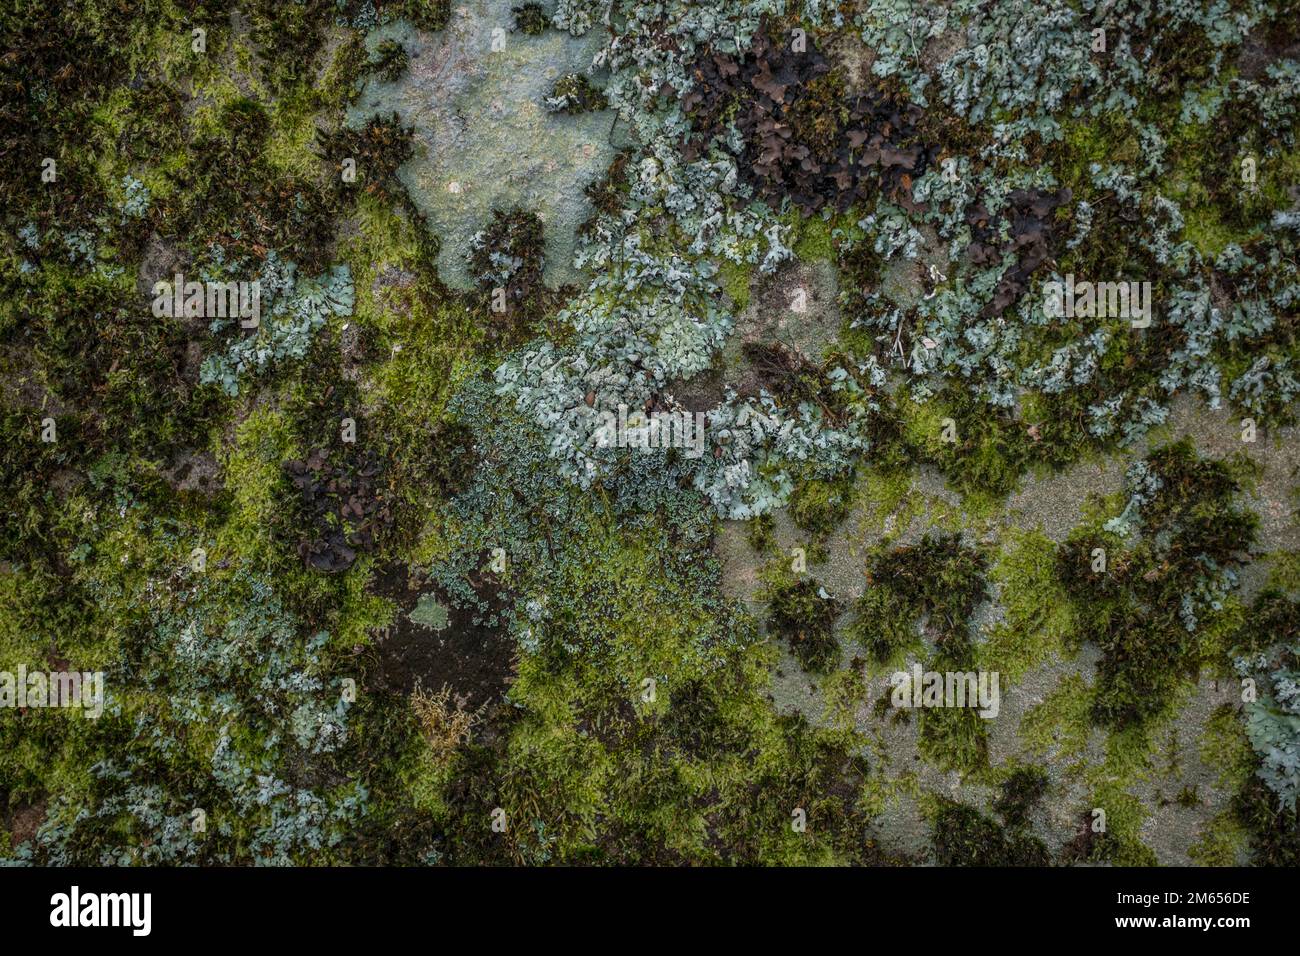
[348,0,615,287]
